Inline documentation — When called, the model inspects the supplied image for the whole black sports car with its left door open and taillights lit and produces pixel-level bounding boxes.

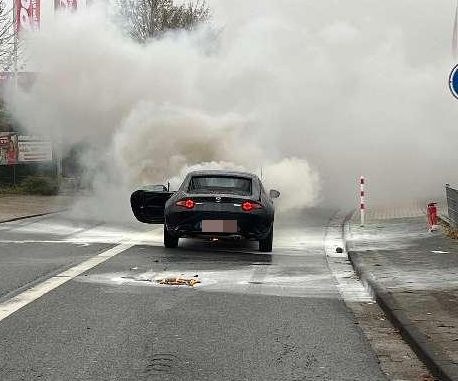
[130,171,280,252]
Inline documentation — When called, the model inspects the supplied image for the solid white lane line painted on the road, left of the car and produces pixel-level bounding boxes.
[0,243,134,321]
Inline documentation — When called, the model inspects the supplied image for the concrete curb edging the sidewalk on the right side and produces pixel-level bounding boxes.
[344,220,458,381]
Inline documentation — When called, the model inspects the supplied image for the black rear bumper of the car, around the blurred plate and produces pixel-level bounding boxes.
[165,210,273,240]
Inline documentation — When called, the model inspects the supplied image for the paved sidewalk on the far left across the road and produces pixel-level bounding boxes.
[0,195,74,222]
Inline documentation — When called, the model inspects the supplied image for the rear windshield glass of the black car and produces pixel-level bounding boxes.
[188,176,251,196]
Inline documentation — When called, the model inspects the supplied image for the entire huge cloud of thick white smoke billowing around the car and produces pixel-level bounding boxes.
[6,0,458,220]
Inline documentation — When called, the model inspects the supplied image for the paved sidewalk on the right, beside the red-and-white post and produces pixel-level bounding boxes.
[346,209,458,380]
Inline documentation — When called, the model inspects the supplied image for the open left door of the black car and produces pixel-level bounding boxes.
[130,185,175,224]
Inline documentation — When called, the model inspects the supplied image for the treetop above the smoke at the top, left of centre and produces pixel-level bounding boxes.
[118,0,210,42]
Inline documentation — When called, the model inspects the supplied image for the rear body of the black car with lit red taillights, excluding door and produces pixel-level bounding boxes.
[165,175,273,240]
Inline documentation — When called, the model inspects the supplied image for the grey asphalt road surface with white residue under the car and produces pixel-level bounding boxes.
[0,210,385,381]
